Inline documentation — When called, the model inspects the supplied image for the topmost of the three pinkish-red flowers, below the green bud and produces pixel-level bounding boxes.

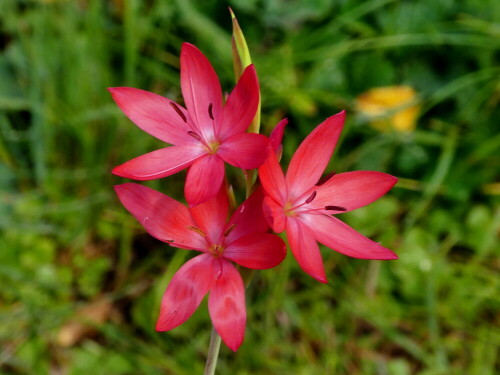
[109,43,268,205]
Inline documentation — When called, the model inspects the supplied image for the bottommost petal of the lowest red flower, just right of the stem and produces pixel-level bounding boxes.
[208,259,246,351]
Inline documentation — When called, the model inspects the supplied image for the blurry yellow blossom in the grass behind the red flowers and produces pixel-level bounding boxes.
[356,86,420,132]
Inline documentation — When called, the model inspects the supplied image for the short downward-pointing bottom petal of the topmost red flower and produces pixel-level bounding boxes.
[184,155,224,206]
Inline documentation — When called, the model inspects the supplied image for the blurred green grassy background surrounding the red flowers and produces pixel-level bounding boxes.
[0,0,500,375]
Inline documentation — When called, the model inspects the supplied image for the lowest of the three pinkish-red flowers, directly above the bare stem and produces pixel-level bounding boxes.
[115,183,286,350]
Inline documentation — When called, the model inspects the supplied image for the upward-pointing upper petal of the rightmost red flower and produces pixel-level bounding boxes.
[286,111,345,200]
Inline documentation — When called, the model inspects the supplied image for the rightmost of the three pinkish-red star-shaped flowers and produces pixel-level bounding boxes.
[259,112,397,283]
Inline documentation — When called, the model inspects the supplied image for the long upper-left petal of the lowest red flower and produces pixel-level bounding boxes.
[115,183,206,251]
